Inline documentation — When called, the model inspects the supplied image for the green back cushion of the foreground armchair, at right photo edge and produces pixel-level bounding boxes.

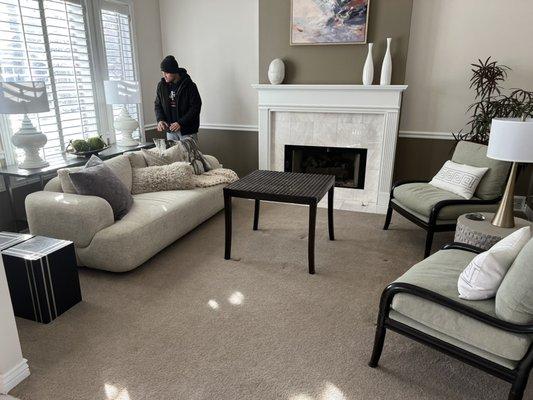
[496,239,533,324]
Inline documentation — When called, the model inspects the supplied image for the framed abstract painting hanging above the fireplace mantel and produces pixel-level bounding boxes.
[291,0,370,45]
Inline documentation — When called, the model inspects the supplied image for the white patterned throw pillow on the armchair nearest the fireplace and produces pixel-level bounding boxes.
[429,161,488,199]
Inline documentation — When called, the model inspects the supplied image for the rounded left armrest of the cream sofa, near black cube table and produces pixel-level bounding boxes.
[25,191,115,247]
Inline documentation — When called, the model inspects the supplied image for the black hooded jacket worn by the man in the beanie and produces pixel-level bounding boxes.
[154,68,202,135]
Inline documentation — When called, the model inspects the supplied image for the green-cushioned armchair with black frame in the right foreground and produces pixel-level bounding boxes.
[369,240,533,400]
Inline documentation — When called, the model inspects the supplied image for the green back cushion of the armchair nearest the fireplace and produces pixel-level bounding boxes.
[452,141,511,200]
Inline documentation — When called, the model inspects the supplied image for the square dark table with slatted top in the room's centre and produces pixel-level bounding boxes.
[224,170,335,274]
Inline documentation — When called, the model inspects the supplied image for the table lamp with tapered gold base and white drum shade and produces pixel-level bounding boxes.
[487,118,533,228]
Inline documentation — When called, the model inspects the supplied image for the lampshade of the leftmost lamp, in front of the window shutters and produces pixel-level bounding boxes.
[0,82,50,114]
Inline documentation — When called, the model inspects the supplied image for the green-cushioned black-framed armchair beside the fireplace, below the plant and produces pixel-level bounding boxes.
[383,141,511,257]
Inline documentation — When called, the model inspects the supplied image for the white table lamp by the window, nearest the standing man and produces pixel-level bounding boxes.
[104,81,141,147]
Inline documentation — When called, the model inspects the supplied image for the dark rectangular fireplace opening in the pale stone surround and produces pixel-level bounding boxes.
[285,145,367,189]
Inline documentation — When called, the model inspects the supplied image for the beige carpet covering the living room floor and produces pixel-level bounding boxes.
[12,201,533,400]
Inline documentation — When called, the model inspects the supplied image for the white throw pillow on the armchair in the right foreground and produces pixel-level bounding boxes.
[457,226,531,300]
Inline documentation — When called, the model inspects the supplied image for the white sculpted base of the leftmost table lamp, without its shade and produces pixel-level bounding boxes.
[11,115,50,169]
